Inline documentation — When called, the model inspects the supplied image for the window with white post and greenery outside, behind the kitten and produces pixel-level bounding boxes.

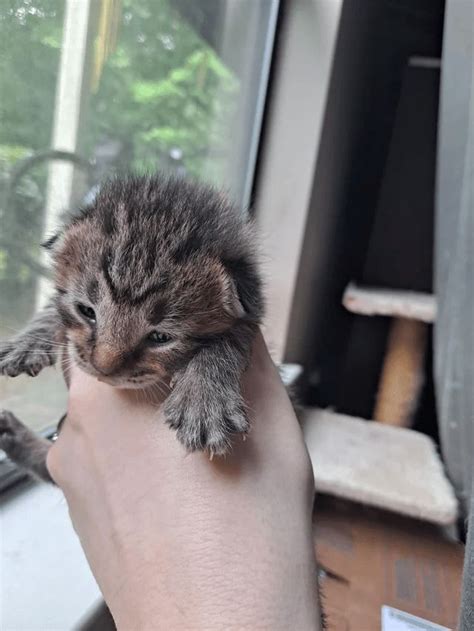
[0,0,278,429]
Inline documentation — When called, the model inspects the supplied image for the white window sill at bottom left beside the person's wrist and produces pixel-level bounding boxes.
[0,482,101,631]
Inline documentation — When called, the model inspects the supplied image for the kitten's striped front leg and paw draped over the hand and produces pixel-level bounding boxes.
[165,325,256,455]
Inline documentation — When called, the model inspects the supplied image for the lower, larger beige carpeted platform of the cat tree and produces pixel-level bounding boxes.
[304,409,457,525]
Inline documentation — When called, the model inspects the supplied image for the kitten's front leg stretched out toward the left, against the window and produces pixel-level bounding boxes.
[0,304,58,377]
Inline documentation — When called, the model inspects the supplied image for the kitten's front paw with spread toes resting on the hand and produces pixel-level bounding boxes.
[165,383,249,456]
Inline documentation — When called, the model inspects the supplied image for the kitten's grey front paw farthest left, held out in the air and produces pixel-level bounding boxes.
[0,340,56,377]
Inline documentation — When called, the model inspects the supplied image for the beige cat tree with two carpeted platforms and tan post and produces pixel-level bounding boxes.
[303,286,458,526]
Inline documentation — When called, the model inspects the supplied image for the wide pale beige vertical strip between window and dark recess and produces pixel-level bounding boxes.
[254,0,343,362]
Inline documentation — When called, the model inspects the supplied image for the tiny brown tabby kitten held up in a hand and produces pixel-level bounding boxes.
[0,175,263,478]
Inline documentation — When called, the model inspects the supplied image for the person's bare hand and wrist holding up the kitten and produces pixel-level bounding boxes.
[47,336,319,631]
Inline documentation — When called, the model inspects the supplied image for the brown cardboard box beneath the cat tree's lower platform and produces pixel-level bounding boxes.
[314,495,464,631]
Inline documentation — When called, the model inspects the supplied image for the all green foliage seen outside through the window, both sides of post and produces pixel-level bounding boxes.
[0,0,239,321]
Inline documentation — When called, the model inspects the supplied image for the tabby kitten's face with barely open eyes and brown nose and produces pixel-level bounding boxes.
[54,220,242,388]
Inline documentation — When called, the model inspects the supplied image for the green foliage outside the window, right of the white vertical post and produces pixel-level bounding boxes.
[84,0,238,181]
